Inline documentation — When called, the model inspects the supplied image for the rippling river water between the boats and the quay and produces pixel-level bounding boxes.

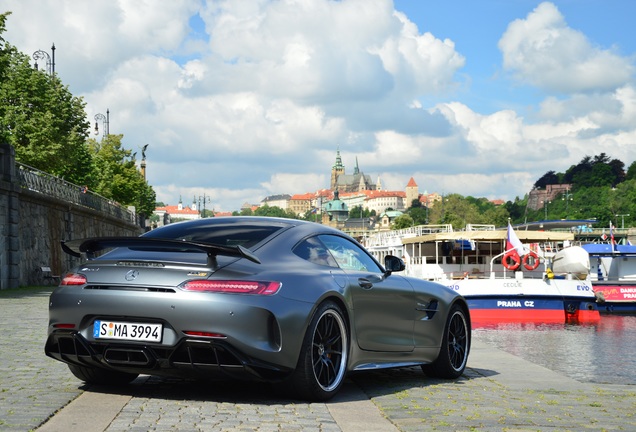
[473,315,636,385]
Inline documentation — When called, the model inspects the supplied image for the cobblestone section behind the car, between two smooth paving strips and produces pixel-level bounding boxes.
[107,379,341,432]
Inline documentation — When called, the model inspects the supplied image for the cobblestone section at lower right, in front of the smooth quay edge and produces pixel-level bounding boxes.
[356,369,636,432]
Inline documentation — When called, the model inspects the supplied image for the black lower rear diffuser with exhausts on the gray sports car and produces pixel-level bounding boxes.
[44,331,292,381]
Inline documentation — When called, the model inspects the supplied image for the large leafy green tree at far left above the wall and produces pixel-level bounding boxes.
[0,13,94,184]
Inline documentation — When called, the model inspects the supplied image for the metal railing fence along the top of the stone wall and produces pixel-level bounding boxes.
[16,163,137,223]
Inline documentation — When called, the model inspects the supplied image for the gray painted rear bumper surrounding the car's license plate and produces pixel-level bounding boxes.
[48,287,313,369]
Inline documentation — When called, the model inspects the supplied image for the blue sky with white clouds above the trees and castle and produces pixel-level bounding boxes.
[0,0,636,211]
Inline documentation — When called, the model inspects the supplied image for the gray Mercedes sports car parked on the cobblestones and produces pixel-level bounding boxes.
[45,217,471,401]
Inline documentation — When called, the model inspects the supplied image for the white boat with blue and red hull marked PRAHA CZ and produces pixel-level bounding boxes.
[364,225,600,326]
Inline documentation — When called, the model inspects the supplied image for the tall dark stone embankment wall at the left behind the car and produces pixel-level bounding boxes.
[0,144,142,289]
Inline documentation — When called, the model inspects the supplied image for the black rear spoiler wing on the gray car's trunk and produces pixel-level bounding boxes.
[61,237,261,267]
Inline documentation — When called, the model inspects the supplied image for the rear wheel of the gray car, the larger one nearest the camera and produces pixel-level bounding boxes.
[289,301,349,401]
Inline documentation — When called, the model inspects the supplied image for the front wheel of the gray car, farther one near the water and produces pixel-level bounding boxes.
[422,305,470,379]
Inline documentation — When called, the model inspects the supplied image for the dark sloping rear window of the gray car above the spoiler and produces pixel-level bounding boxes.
[144,224,283,249]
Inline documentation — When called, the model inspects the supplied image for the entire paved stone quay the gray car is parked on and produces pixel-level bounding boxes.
[0,290,636,432]
